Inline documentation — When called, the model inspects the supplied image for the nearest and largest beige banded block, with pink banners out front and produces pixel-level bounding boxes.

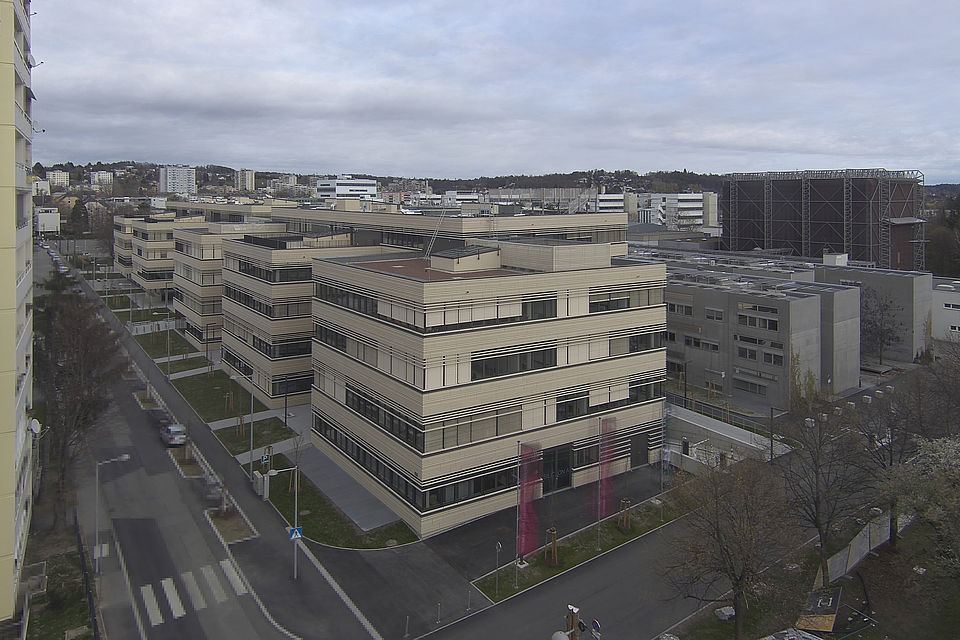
[312,239,665,536]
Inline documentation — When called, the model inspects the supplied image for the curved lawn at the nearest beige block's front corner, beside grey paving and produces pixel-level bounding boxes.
[270,454,417,549]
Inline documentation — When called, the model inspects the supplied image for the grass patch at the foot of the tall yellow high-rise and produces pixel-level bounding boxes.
[27,551,93,640]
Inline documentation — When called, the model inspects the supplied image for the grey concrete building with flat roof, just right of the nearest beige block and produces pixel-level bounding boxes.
[665,264,860,409]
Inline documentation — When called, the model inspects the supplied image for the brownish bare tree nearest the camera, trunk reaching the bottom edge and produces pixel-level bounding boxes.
[663,460,796,639]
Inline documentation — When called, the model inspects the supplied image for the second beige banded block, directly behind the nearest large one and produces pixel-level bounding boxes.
[222,232,390,408]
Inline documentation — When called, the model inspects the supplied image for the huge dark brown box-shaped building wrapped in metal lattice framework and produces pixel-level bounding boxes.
[720,169,925,270]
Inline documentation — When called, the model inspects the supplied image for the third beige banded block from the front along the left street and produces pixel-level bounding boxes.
[173,222,285,352]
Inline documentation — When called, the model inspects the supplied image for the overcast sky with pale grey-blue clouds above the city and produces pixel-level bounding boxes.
[31,0,960,184]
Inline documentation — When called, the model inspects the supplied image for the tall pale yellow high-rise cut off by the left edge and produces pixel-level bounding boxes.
[0,0,37,620]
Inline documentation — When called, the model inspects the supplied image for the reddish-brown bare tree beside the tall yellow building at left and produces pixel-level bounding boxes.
[35,292,122,524]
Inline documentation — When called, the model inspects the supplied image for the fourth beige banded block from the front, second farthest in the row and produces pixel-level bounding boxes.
[130,213,205,299]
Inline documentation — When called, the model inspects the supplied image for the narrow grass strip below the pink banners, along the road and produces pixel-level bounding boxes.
[474,498,682,602]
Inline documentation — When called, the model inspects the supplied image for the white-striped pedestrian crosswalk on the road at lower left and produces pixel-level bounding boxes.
[140,558,249,627]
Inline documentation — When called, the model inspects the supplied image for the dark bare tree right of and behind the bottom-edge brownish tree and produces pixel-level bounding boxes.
[777,412,867,586]
